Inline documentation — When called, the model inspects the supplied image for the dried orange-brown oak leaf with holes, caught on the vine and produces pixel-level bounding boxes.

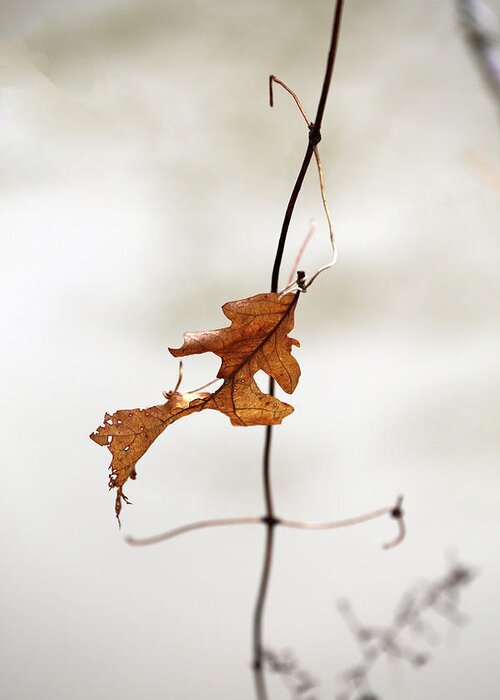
[90,293,300,519]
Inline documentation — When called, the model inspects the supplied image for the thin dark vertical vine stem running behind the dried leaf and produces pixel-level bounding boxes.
[253,0,344,682]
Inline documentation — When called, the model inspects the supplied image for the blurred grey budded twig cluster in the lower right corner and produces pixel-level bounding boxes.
[336,564,476,700]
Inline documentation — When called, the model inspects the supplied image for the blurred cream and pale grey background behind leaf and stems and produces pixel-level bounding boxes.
[0,0,500,700]
